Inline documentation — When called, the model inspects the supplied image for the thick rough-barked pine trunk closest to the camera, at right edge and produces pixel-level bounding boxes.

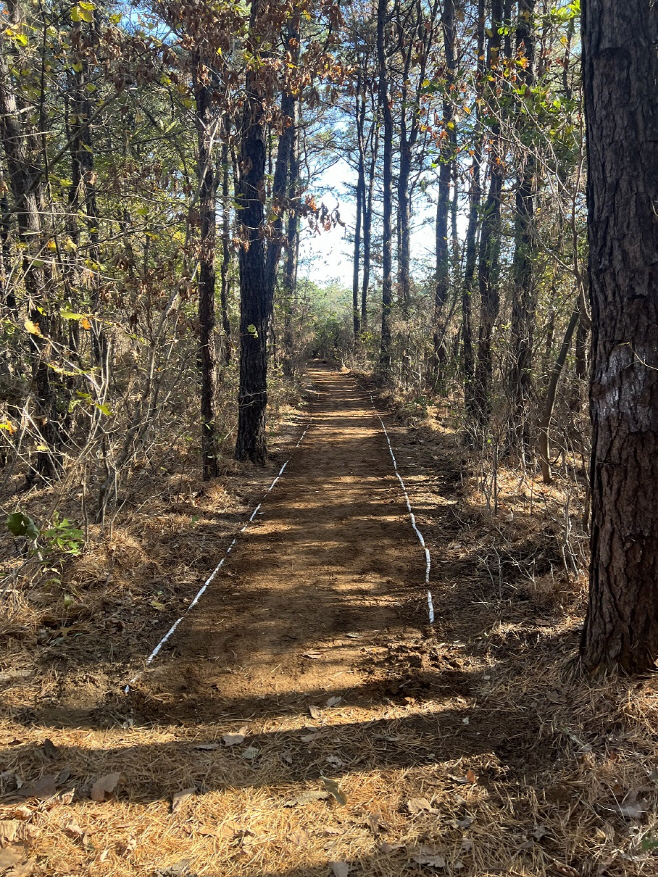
[582,0,658,672]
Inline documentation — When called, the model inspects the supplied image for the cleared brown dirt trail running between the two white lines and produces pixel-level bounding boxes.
[141,368,425,721]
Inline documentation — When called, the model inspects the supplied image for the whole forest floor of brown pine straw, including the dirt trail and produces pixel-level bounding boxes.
[0,365,658,877]
